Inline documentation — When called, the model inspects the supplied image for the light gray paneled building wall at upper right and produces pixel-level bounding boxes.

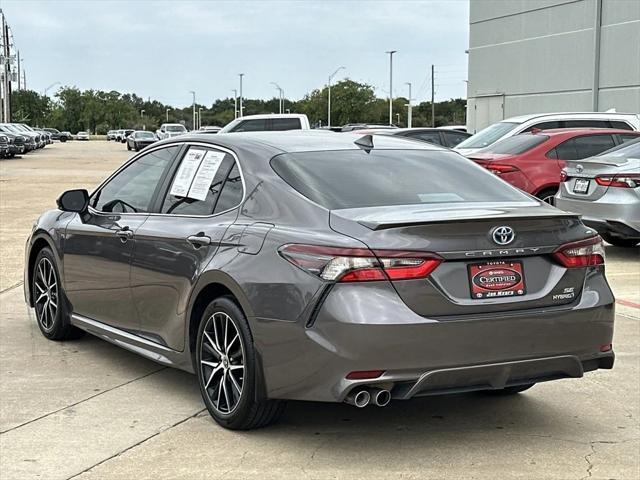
[467,0,640,132]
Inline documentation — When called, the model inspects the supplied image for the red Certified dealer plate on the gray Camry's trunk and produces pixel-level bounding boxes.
[469,261,527,300]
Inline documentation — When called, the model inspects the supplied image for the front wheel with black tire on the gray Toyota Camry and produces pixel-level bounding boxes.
[31,247,84,340]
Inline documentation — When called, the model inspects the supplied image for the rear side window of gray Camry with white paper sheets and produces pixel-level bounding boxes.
[161,147,242,215]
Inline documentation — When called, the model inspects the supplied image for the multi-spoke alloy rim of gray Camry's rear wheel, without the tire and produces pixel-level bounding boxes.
[200,312,245,415]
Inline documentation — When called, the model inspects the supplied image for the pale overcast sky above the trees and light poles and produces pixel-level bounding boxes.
[0,0,469,106]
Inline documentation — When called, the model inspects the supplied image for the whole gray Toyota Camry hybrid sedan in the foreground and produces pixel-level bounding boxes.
[24,131,614,429]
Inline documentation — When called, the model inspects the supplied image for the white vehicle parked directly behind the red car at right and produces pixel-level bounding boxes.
[455,112,640,155]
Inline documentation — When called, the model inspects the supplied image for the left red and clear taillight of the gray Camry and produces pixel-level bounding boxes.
[279,244,442,282]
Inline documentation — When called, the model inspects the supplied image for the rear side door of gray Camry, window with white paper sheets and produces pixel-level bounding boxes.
[131,144,244,351]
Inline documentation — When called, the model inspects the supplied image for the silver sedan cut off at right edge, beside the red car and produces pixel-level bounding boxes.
[555,139,640,247]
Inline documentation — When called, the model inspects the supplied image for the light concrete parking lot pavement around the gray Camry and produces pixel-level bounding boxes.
[0,142,640,480]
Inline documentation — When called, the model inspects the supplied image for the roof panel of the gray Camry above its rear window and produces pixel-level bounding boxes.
[160,130,449,155]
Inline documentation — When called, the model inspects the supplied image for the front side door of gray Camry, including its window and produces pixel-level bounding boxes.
[63,146,179,330]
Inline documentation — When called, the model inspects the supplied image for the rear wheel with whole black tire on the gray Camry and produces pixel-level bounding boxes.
[195,297,285,430]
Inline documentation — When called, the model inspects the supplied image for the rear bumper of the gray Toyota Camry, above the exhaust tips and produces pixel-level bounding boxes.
[250,273,615,402]
